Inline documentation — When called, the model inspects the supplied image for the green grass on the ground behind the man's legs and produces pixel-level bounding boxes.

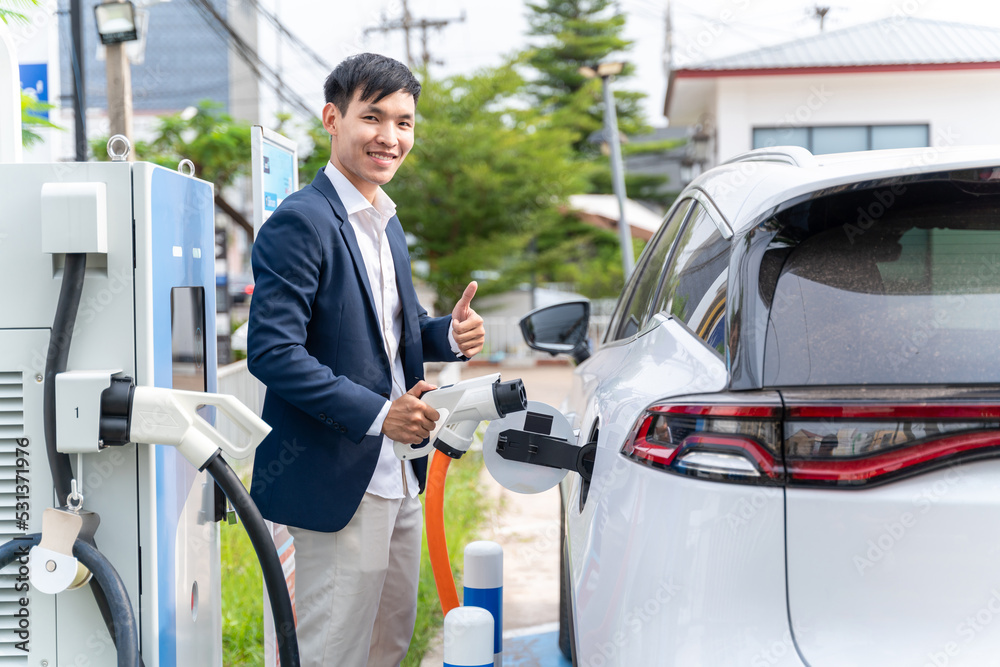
[221,452,486,667]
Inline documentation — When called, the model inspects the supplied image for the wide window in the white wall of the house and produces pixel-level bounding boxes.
[753,125,930,155]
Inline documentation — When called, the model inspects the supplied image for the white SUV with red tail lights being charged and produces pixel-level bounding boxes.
[522,147,1000,667]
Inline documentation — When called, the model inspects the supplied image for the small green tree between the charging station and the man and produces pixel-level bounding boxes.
[91,100,253,243]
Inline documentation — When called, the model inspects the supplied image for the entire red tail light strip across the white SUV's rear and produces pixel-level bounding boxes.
[622,394,1000,488]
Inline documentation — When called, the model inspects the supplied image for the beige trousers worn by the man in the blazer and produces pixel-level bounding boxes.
[288,493,423,667]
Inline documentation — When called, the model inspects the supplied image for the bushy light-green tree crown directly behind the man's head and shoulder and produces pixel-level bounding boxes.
[386,65,584,312]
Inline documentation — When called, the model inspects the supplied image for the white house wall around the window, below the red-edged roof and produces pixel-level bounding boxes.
[707,69,1000,163]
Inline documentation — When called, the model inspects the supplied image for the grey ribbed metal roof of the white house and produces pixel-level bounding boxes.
[677,16,1000,74]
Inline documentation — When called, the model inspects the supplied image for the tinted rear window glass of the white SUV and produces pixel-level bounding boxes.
[762,193,1000,386]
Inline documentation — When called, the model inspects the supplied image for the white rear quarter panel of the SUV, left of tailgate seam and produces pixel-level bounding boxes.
[567,315,801,666]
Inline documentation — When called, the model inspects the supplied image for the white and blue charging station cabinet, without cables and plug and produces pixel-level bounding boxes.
[0,162,222,667]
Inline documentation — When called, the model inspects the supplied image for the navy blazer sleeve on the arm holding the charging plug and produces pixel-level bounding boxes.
[247,208,386,442]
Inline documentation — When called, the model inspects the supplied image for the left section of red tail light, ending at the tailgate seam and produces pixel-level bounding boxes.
[622,396,783,484]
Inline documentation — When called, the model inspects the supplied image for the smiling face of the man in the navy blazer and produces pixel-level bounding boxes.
[323,90,416,201]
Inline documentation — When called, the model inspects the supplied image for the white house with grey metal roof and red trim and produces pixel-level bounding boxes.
[664,15,1000,167]
